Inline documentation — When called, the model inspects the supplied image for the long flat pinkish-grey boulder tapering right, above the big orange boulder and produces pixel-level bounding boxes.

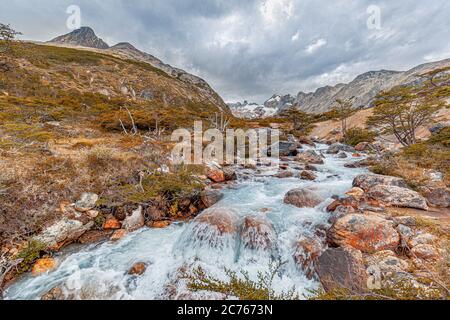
[367,185,428,210]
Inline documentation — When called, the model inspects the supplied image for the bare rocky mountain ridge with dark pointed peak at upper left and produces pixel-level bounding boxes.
[49,27,228,111]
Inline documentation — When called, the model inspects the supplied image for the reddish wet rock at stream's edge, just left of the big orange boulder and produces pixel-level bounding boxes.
[293,236,324,279]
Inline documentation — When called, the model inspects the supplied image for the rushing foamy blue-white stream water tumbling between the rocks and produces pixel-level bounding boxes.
[5,146,364,299]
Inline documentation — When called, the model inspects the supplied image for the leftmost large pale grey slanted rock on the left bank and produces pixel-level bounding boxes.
[35,218,94,247]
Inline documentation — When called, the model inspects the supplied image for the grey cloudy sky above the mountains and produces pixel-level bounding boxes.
[0,0,450,103]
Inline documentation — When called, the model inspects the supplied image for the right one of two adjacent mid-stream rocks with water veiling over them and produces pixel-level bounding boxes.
[240,216,277,251]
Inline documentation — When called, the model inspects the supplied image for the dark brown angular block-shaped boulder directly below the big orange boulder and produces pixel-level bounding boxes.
[315,248,367,292]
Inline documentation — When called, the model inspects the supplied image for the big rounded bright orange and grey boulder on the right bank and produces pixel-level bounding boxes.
[327,214,400,253]
